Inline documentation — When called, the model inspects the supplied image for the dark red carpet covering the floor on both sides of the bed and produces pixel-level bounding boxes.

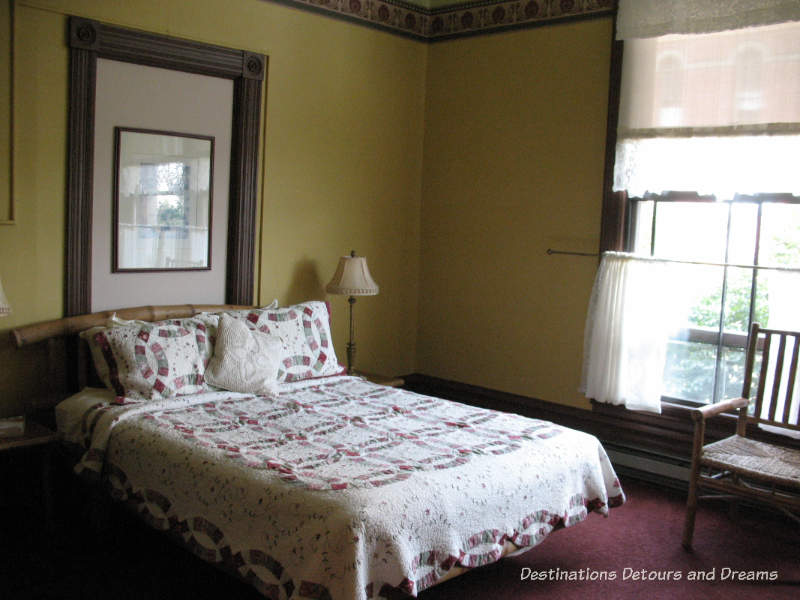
[0,469,800,600]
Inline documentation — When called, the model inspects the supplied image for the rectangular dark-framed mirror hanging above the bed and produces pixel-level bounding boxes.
[112,127,214,273]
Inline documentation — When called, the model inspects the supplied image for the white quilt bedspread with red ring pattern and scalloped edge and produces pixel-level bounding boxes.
[65,377,624,600]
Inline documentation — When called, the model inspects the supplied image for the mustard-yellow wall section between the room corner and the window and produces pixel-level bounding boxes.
[417,19,611,406]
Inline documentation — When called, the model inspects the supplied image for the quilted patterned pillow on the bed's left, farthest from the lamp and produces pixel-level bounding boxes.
[81,322,206,400]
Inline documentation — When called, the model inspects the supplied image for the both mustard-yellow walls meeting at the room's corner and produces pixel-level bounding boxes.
[0,0,611,414]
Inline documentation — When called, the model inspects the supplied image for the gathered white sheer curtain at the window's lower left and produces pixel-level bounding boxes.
[581,252,688,413]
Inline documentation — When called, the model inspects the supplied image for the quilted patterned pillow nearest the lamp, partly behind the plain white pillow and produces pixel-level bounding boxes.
[229,301,345,382]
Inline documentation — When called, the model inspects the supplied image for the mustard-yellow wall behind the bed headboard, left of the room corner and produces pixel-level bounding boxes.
[0,0,427,414]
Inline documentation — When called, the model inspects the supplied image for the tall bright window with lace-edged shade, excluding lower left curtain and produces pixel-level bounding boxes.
[613,22,800,404]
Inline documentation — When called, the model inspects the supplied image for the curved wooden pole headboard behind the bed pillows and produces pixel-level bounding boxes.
[11,304,252,408]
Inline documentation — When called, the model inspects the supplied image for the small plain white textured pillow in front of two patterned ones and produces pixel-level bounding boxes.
[205,314,283,394]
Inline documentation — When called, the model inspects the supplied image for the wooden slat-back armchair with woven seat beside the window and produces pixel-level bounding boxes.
[683,323,800,549]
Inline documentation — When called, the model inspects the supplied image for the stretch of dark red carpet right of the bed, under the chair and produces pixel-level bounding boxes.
[420,479,800,600]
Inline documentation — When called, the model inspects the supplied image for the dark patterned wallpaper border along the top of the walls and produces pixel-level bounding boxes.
[265,0,617,42]
